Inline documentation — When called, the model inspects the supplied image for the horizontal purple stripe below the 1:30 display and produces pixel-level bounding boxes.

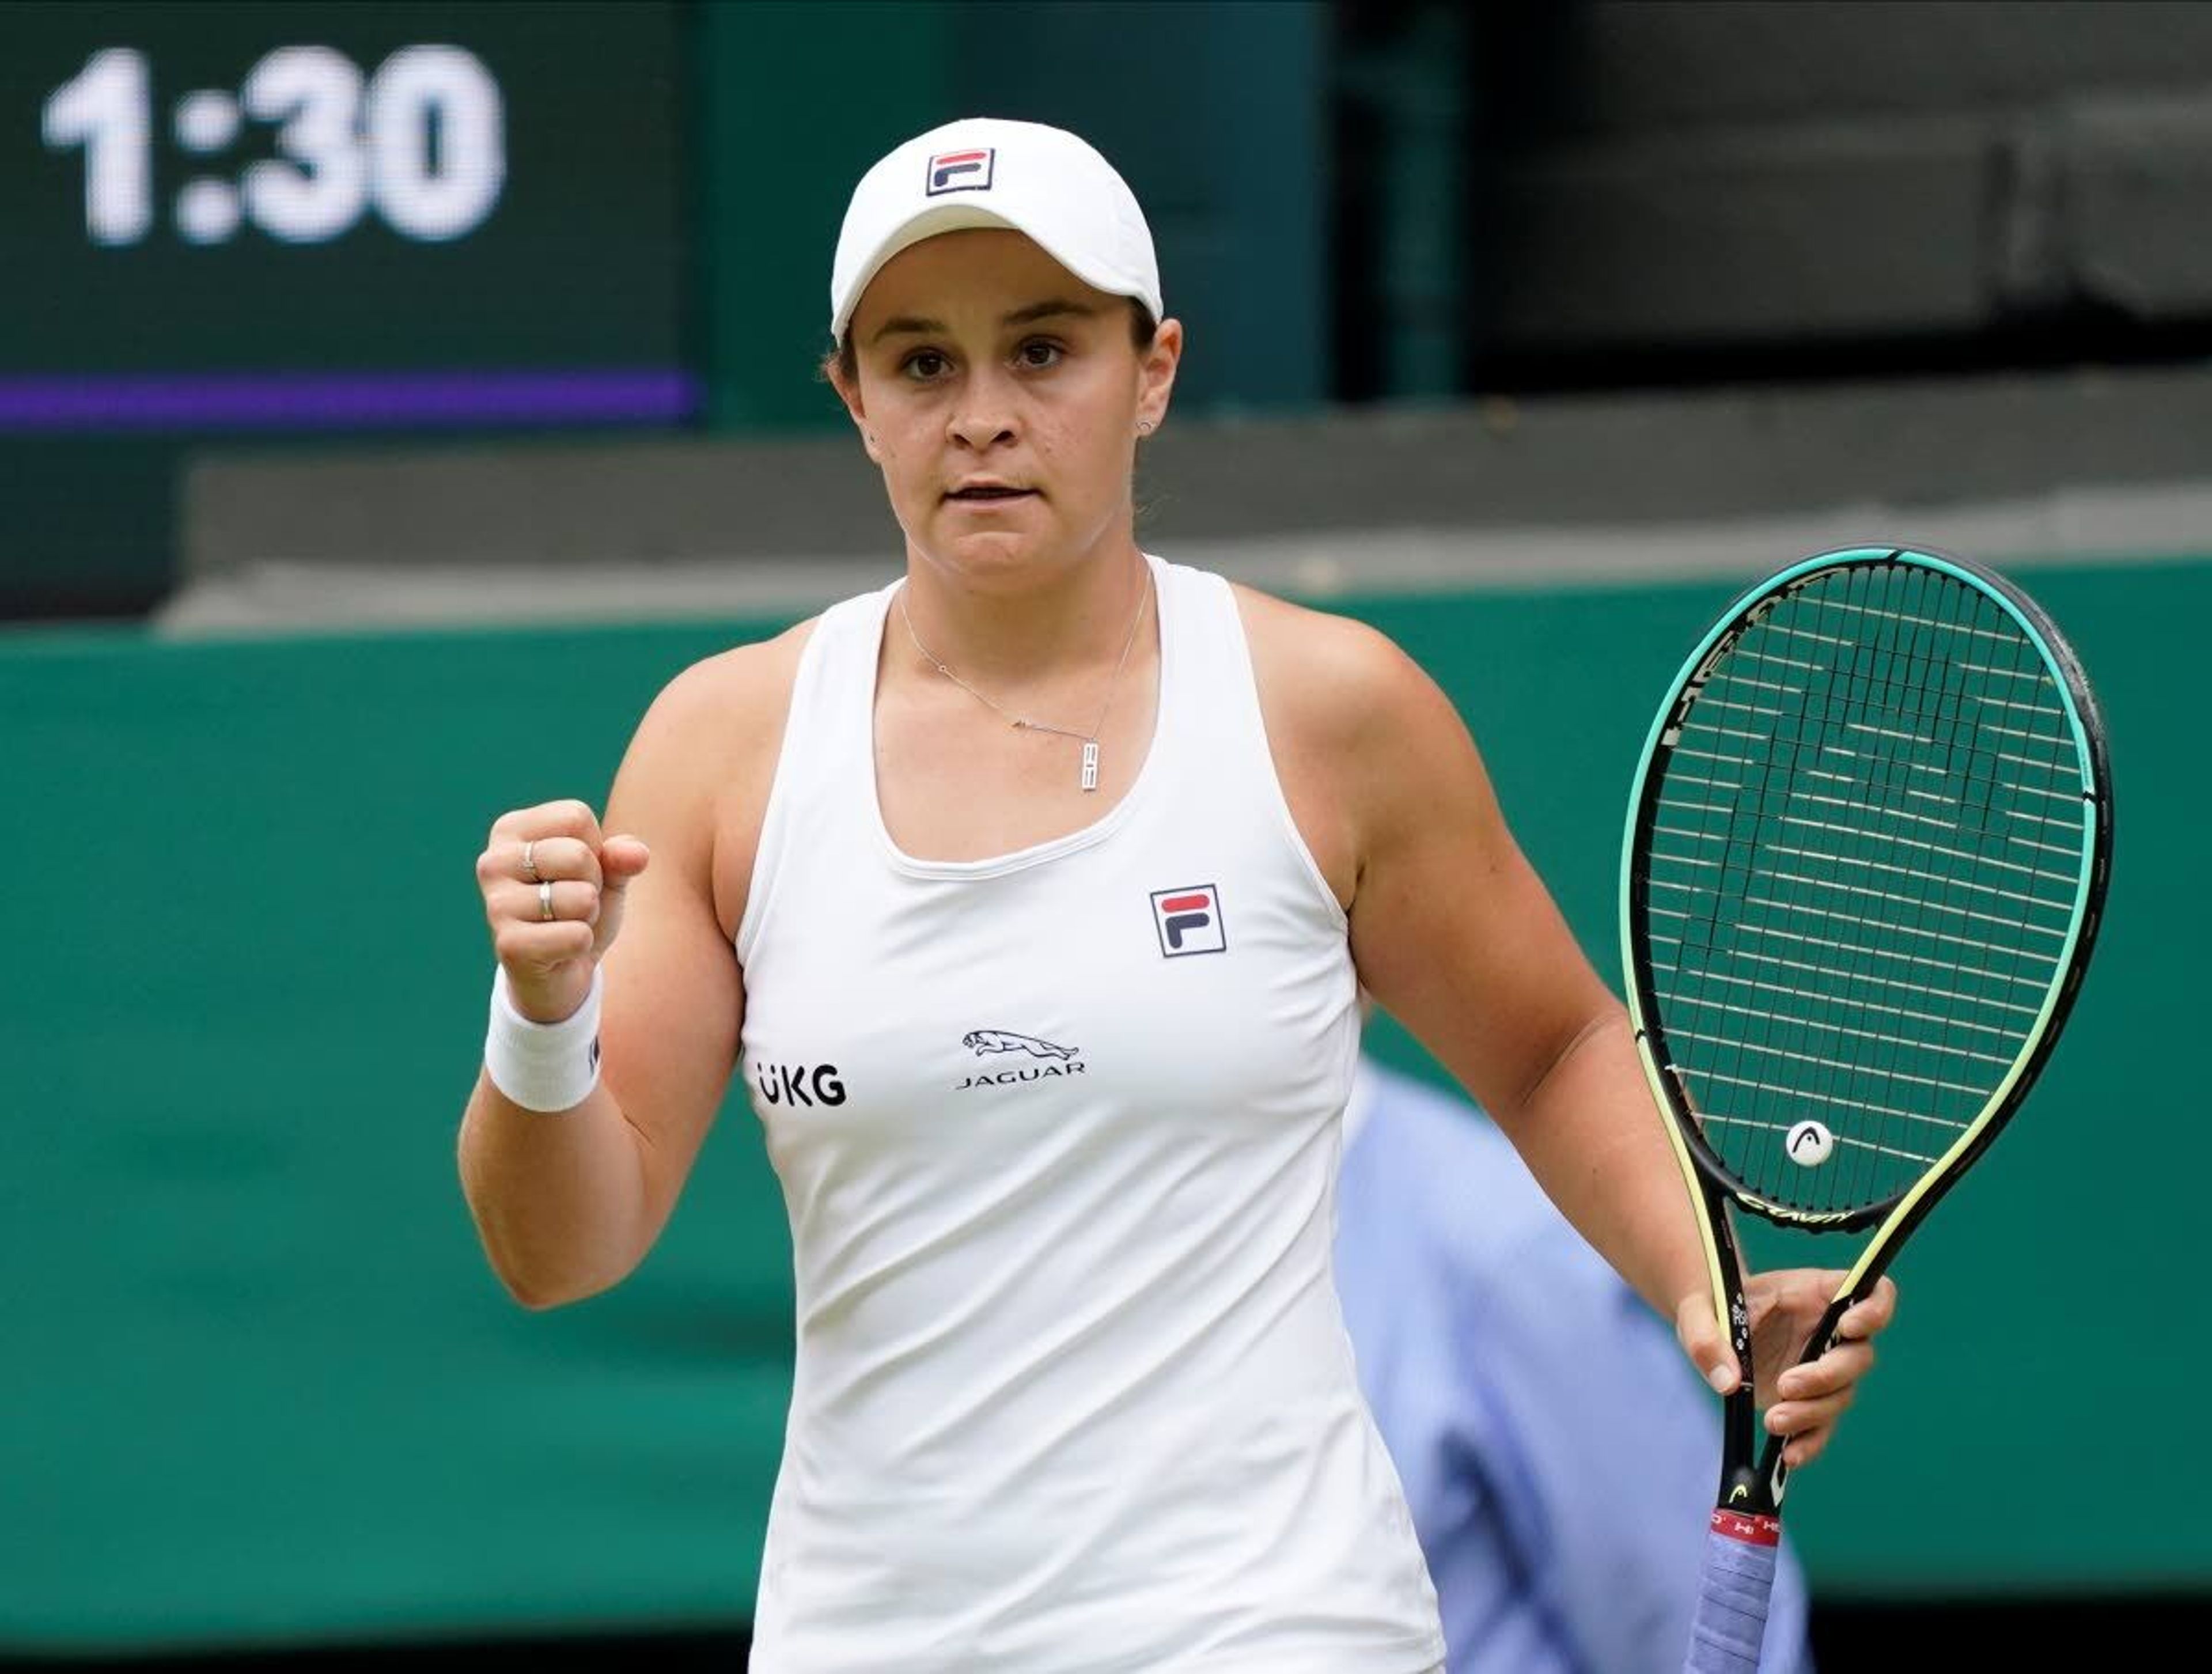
[0,367,699,431]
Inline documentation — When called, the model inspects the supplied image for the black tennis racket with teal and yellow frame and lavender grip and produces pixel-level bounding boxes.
[1622,546,2112,1674]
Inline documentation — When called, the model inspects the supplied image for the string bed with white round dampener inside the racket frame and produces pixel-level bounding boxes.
[1643,564,2084,1212]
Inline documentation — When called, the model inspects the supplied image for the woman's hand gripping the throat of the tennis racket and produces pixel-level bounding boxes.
[1675,1267,1898,1471]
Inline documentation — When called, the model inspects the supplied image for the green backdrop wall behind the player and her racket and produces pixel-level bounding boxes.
[0,562,2212,1650]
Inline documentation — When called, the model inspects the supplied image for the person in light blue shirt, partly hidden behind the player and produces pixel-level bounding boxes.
[1336,1057,1812,1674]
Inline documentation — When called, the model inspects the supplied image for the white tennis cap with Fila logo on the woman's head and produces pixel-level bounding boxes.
[830,117,1161,338]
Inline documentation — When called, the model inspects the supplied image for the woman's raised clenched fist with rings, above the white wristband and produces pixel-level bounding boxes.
[476,802,653,1024]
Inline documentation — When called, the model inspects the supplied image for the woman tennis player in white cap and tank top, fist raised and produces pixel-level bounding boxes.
[460,119,1893,1674]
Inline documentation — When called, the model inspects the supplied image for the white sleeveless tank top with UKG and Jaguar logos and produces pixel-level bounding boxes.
[737,559,1445,1674]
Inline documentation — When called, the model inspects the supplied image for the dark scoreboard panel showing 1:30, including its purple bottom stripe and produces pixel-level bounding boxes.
[0,0,697,435]
